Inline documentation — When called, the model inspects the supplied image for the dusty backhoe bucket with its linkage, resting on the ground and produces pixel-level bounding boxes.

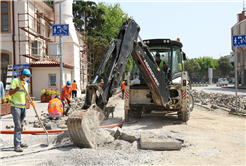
[67,85,104,149]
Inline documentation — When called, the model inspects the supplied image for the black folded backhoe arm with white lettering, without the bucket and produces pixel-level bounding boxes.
[84,19,170,110]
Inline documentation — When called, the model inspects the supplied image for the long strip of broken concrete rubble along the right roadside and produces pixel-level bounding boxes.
[193,90,246,114]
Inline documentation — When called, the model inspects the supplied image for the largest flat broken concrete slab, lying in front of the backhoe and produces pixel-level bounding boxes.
[140,131,182,150]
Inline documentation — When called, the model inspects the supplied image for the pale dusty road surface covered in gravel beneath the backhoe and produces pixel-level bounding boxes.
[0,97,246,166]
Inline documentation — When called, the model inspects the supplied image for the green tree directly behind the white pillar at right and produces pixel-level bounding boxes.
[195,56,219,79]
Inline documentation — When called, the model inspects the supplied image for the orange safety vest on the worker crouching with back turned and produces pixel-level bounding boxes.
[48,98,63,116]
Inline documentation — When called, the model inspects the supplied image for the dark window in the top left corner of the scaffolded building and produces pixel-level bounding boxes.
[0,1,10,31]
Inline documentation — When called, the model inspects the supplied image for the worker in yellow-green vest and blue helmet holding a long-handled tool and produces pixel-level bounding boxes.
[9,69,35,152]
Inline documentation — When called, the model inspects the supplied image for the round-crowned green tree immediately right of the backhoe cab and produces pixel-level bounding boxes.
[184,59,201,87]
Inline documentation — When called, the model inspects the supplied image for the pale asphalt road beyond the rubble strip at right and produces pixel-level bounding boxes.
[192,84,246,97]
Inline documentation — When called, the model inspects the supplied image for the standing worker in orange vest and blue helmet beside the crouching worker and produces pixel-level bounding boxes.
[60,81,72,116]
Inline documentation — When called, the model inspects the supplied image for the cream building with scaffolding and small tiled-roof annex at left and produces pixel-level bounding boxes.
[0,0,88,99]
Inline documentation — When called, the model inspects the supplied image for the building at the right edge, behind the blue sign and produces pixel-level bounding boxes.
[231,11,246,86]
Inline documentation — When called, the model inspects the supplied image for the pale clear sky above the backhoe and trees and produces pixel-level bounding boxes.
[95,0,245,59]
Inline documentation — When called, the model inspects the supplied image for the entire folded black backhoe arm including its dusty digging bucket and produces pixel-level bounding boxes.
[67,19,170,148]
